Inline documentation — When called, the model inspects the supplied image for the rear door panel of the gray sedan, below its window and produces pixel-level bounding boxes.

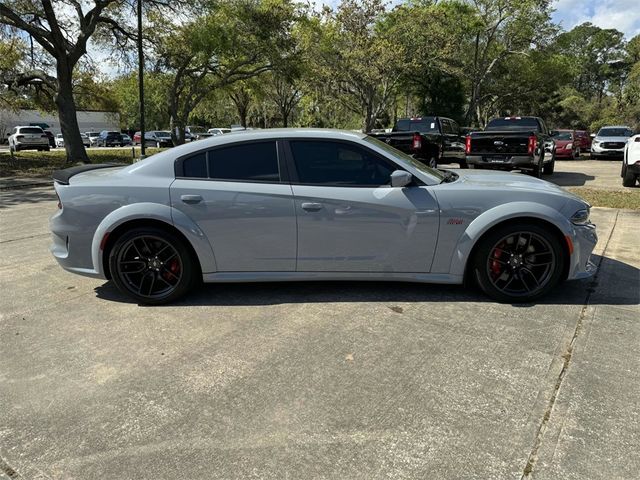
[171,178,296,272]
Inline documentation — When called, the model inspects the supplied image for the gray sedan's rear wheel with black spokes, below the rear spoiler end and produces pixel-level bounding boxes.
[109,227,198,305]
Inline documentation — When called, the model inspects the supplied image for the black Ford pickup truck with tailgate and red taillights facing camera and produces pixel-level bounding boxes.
[465,117,555,178]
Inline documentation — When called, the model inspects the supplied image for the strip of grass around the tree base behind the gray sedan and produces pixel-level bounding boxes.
[0,148,163,177]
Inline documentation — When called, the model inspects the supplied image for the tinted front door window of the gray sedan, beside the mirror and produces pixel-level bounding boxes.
[290,140,395,186]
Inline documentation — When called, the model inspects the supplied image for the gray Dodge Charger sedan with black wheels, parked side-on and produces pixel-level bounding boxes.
[50,129,597,304]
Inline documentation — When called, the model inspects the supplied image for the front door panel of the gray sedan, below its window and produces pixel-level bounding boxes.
[292,185,439,272]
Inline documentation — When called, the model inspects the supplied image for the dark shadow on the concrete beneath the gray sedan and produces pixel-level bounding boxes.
[95,255,640,308]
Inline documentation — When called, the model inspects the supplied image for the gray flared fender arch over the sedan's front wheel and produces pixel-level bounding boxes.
[449,202,574,275]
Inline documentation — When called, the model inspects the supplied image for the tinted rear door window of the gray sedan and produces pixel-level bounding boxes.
[209,142,280,182]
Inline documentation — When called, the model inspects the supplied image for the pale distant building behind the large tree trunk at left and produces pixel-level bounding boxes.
[0,109,120,142]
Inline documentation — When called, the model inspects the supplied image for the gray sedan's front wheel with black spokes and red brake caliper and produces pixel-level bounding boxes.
[471,222,564,303]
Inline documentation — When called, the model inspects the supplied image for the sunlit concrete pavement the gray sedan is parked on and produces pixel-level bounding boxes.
[0,189,640,480]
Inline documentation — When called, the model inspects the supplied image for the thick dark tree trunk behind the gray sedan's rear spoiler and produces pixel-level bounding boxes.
[54,64,91,163]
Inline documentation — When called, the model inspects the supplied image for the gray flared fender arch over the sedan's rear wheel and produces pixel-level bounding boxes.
[91,202,216,277]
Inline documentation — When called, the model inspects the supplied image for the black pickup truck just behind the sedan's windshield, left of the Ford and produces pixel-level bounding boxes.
[368,117,467,168]
